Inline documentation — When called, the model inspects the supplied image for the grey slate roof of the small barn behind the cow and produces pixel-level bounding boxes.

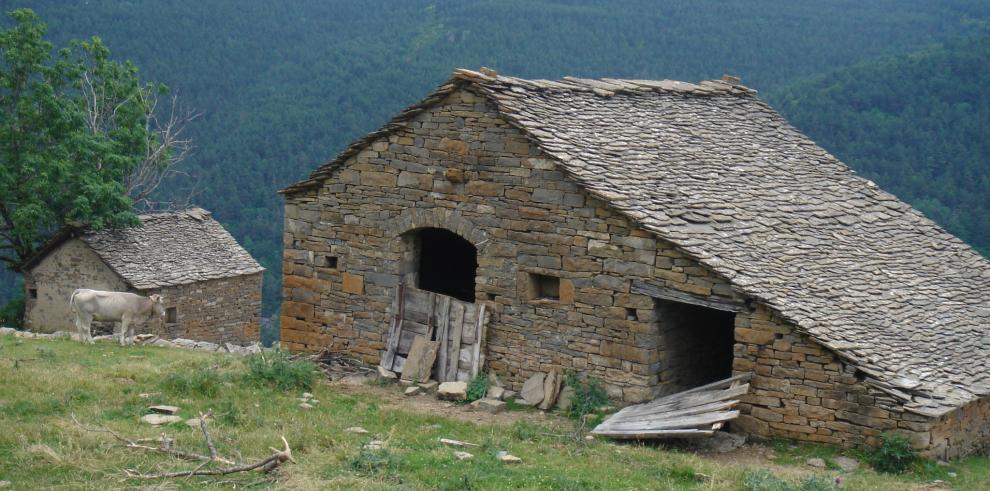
[79,208,265,290]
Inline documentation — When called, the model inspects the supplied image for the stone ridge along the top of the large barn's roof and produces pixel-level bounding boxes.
[453,67,757,97]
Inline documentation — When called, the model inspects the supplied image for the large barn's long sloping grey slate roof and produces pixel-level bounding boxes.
[284,70,990,416]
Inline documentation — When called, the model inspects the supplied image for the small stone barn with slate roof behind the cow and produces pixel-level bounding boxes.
[22,208,264,344]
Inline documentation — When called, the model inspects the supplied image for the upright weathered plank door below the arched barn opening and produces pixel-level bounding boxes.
[381,284,489,382]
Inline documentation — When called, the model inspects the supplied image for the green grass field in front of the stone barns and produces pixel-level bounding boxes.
[0,336,990,490]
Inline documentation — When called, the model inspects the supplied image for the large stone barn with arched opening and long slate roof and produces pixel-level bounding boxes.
[281,70,990,458]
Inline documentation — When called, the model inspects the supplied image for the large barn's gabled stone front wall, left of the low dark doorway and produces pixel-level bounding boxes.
[281,90,737,401]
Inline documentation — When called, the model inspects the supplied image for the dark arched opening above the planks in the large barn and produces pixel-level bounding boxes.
[416,228,478,303]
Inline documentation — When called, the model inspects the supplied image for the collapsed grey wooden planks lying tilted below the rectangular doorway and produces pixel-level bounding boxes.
[591,374,750,439]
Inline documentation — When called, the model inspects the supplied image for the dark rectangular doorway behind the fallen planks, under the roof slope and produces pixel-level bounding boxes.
[656,300,735,394]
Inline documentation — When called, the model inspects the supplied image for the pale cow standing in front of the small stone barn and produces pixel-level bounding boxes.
[69,288,165,346]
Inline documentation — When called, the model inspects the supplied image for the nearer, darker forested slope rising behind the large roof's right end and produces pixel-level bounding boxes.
[769,33,990,256]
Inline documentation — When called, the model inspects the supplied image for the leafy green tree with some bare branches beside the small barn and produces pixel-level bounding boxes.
[0,9,196,270]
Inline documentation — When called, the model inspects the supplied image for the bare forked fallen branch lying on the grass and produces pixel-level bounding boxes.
[72,411,295,479]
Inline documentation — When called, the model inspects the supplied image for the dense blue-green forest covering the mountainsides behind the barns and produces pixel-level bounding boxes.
[0,0,990,322]
